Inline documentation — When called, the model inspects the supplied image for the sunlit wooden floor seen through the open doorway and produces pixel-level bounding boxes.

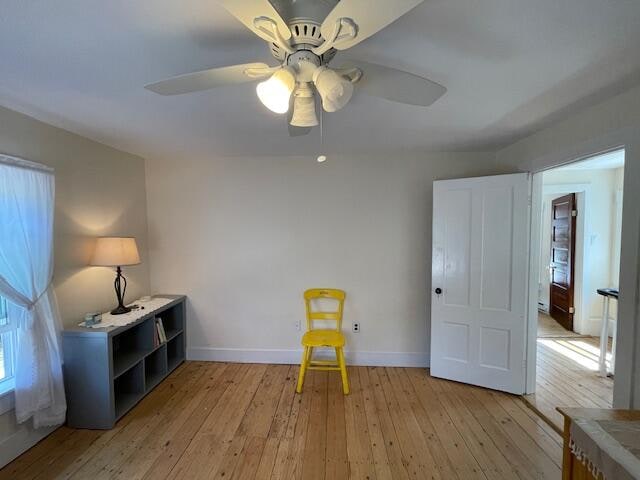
[525,316,613,431]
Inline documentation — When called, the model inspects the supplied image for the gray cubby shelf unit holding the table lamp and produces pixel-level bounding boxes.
[62,295,187,429]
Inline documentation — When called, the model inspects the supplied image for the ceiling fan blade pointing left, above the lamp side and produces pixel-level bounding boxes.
[144,63,270,95]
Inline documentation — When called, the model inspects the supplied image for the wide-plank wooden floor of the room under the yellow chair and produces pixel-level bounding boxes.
[0,362,561,480]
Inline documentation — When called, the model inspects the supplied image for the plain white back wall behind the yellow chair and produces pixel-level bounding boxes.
[147,154,508,365]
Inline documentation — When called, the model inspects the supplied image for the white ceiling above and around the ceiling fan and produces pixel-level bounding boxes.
[0,0,640,157]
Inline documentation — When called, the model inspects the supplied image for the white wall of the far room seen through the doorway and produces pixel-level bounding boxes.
[540,169,621,335]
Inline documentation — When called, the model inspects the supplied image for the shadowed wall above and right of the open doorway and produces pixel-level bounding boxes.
[496,83,640,408]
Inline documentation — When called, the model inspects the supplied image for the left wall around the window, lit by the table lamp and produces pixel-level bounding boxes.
[0,107,149,466]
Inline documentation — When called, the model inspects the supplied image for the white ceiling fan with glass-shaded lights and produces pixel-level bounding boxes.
[145,0,447,136]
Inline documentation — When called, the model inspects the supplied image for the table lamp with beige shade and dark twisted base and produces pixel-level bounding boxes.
[90,237,140,315]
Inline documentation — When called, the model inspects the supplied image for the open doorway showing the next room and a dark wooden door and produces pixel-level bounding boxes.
[525,149,624,430]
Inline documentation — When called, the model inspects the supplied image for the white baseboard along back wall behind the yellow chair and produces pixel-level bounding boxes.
[187,347,429,367]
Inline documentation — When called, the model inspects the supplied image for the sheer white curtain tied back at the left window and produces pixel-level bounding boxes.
[0,155,67,428]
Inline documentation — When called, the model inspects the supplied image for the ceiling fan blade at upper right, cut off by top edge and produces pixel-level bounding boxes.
[320,0,424,50]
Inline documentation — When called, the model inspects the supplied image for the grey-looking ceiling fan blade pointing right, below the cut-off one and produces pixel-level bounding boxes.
[342,60,447,107]
